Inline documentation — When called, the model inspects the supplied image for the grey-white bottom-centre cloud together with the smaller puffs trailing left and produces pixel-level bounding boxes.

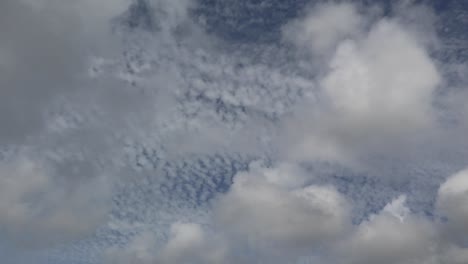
[102,162,351,264]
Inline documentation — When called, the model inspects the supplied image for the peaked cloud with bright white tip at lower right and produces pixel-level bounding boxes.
[337,197,437,264]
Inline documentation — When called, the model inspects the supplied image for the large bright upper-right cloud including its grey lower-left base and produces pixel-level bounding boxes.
[280,7,442,165]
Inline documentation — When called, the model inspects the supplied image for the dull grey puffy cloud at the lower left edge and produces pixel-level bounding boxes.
[0,157,109,247]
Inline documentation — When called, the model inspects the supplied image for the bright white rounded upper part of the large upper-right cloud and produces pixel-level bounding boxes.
[322,20,441,129]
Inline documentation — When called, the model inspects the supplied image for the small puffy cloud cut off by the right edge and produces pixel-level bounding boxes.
[437,170,468,242]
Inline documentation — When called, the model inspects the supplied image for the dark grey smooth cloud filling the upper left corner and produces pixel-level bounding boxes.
[0,0,126,145]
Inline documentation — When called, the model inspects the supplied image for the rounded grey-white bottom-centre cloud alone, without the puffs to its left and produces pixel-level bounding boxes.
[215,163,349,254]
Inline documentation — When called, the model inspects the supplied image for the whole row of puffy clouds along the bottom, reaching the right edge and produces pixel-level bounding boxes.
[109,163,468,264]
